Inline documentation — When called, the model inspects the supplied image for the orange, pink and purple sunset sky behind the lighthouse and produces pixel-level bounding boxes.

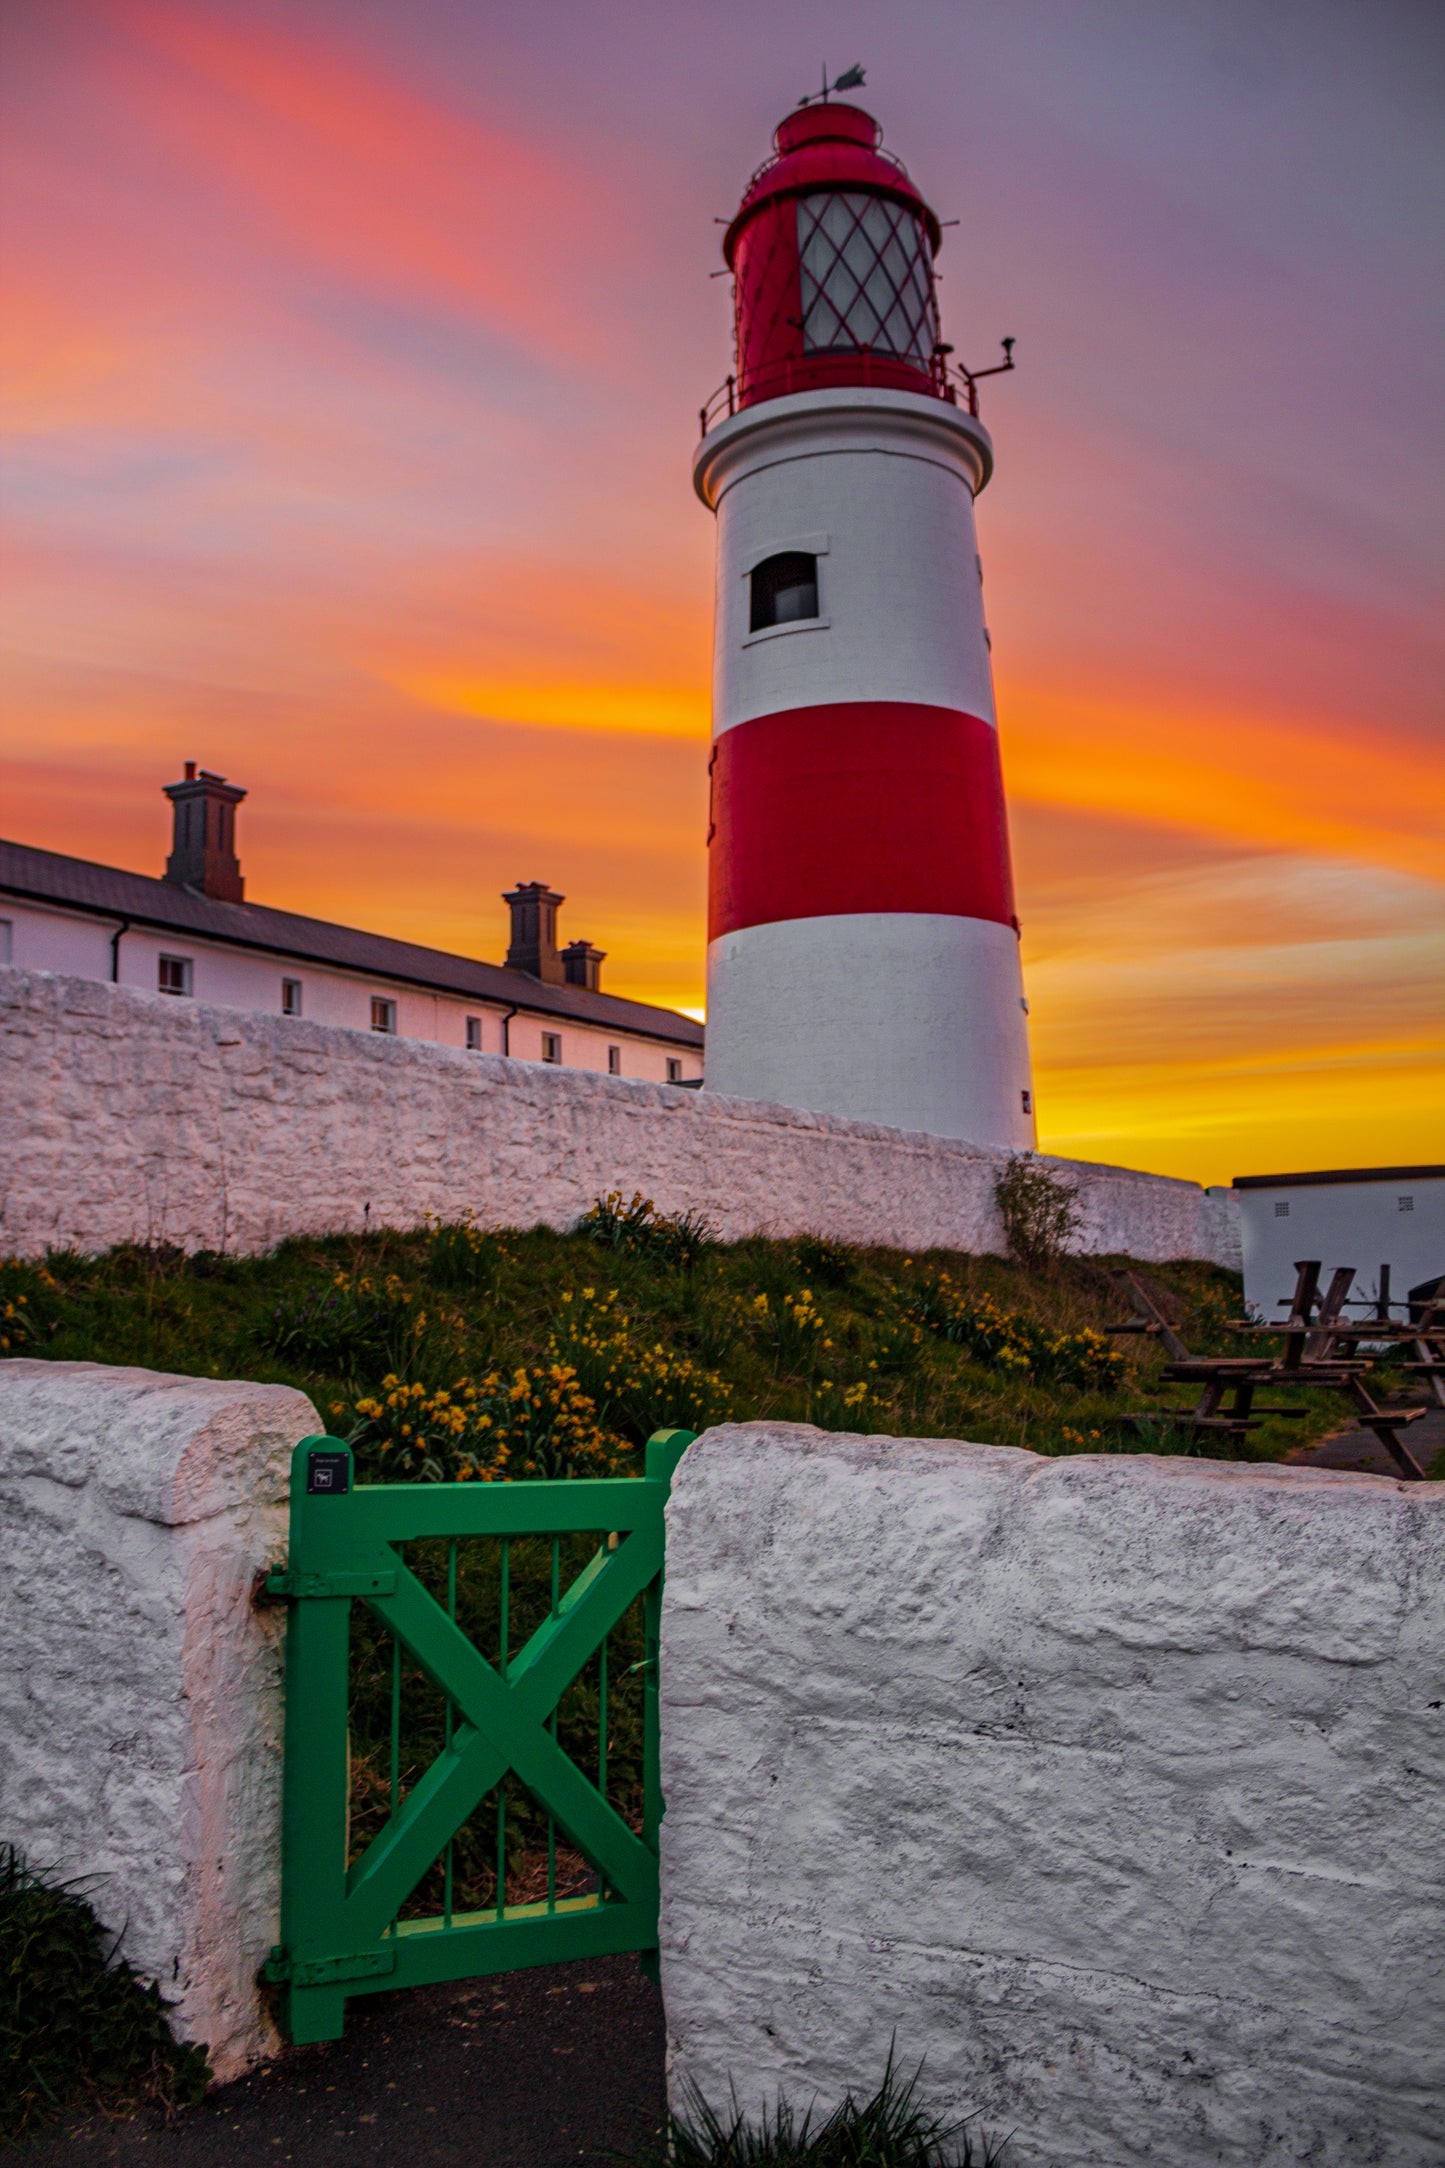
[0,0,1445,1182]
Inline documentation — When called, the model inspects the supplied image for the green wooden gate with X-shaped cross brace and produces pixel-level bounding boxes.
[266,1431,693,2042]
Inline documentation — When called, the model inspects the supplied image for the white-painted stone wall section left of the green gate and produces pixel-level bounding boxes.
[0,1362,323,2079]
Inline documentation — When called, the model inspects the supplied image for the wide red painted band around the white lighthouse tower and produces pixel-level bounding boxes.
[708,700,1018,941]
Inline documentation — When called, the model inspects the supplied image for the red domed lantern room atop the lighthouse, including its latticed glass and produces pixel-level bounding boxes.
[724,100,955,405]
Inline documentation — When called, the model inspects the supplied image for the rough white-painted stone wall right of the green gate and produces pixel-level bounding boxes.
[661,1424,1445,2168]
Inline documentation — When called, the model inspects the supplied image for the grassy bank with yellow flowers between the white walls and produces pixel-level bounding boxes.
[0,1208,1341,1481]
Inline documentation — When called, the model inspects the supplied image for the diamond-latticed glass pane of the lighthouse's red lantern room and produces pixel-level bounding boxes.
[797,193,938,369]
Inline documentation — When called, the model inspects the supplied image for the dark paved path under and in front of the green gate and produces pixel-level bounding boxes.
[0,1958,663,2168]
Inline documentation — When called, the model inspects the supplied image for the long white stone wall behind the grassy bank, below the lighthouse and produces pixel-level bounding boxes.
[0,969,1239,1266]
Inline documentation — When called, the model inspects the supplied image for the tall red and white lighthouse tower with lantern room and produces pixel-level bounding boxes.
[693,95,1036,1149]
